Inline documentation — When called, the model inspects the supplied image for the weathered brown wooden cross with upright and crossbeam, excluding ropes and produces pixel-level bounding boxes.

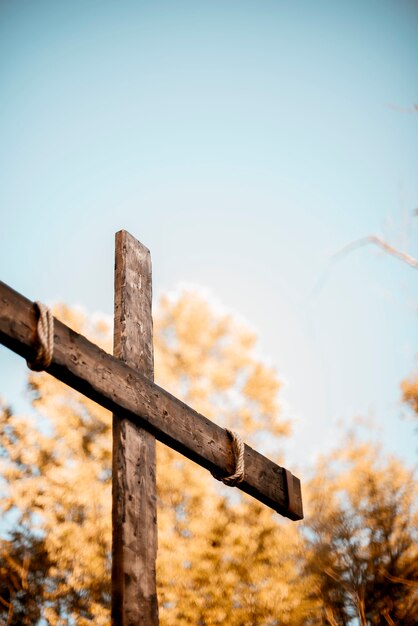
[0,230,303,626]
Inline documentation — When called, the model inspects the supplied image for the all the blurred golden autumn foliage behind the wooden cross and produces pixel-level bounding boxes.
[0,291,418,626]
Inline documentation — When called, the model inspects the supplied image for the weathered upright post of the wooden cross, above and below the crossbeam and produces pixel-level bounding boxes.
[112,230,158,626]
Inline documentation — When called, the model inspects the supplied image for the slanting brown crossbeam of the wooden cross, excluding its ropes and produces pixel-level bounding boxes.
[0,282,303,520]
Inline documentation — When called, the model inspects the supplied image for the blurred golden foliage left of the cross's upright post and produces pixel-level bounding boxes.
[0,307,111,625]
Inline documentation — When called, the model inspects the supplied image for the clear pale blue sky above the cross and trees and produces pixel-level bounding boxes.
[0,0,418,465]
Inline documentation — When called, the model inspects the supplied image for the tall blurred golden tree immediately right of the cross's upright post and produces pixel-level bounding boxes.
[152,292,308,626]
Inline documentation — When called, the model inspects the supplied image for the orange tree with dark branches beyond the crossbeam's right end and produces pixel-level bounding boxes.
[303,428,418,626]
